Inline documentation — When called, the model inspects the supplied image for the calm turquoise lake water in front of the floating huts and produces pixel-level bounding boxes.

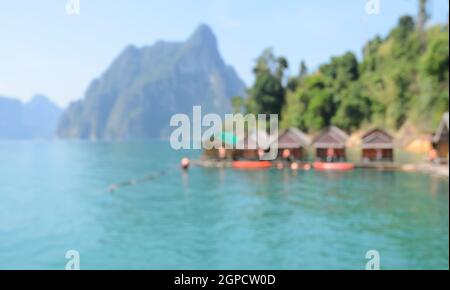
[0,142,449,269]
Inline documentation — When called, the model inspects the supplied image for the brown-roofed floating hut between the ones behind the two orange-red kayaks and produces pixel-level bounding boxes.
[274,128,311,161]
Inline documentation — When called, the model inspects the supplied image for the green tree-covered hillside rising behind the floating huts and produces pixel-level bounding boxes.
[237,14,449,132]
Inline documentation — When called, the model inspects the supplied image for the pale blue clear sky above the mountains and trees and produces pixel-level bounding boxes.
[0,0,448,106]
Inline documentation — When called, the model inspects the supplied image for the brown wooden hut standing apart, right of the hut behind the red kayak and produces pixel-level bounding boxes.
[361,128,394,162]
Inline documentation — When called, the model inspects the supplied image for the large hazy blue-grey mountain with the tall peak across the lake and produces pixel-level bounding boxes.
[58,24,245,140]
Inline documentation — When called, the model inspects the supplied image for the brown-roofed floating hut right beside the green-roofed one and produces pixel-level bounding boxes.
[237,131,272,160]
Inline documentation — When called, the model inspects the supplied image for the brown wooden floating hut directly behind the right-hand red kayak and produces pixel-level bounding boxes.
[312,126,349,162]
